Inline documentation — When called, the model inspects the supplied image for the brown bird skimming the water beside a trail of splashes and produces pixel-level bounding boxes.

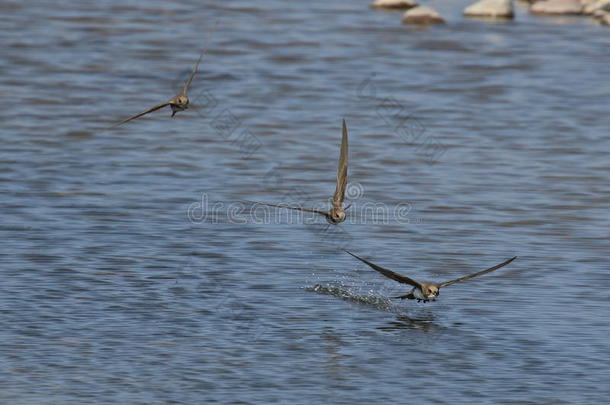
[346,250,517,302]
